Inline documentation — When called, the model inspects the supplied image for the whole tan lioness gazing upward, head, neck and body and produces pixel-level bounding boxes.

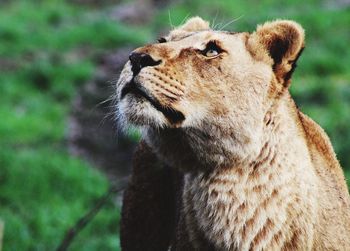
[117,17,350,250]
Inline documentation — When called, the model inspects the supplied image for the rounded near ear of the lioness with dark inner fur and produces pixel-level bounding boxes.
[249,20,305,82]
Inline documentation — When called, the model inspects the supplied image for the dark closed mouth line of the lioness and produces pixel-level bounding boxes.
[120,79,185,124]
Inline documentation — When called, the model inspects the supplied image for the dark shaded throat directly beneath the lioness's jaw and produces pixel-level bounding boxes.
[143,119,259,173]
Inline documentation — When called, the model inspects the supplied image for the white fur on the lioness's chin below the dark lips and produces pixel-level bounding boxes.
[118,94,167,129]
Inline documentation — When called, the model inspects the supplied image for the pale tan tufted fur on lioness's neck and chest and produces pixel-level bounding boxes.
[179,95,316,250]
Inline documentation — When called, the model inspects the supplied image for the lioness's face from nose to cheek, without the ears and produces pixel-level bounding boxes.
[119,26,271,127]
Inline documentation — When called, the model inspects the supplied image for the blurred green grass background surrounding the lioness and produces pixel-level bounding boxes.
[0,0,350,250]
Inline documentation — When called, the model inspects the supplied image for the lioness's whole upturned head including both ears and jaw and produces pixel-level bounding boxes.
[117,17,304,169]
